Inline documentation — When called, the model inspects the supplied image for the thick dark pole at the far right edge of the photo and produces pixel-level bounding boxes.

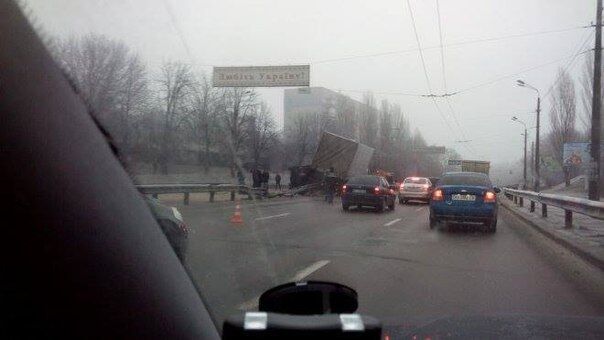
[588,0,602,201]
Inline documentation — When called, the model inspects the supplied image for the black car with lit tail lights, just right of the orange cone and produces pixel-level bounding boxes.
[342,175,396,211]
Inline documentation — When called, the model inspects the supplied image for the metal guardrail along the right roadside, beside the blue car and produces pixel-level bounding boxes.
[503,188,604,228]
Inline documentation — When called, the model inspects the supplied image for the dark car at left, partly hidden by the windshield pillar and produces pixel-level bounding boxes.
[143,195,189,263]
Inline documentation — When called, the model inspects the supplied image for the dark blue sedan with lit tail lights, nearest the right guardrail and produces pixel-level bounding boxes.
[430,172,499,233]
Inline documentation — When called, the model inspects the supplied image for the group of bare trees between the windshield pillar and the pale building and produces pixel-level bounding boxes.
[53,34,280,175]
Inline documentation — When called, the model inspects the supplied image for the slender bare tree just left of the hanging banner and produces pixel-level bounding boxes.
[156,62,193,174]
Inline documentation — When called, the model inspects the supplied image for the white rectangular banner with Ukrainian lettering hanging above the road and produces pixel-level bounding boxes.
[212,65,310,87]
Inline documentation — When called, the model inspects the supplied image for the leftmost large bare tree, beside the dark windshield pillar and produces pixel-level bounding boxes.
[52,34,148,152]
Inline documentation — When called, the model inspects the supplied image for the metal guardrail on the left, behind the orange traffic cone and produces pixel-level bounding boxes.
[136,184,251,205]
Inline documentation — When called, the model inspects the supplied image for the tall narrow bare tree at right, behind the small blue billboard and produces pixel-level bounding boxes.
[549,69,577,164]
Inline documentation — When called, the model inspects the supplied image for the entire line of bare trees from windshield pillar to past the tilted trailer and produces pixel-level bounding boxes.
[52,34,439,179]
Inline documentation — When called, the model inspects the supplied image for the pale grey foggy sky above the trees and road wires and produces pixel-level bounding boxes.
[24,0,596,162]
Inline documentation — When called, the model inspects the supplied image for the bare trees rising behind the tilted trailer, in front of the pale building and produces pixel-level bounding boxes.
[284,92,442,176]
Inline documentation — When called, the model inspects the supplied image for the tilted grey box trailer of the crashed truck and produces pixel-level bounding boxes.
[311,132,374,179]
